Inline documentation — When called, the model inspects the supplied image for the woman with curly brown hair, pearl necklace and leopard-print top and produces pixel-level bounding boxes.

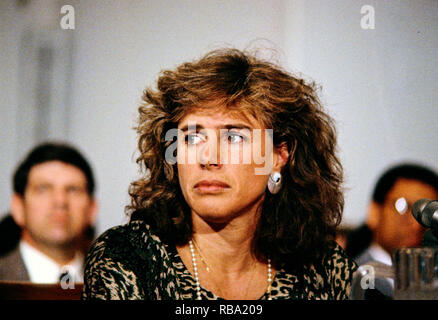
[83,49,356,299]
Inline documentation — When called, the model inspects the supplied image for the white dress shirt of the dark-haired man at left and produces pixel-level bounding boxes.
[20,241,84,283]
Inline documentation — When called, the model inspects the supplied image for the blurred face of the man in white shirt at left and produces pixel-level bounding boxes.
[14,161,96,246]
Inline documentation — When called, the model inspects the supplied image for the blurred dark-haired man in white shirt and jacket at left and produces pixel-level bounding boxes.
[0,143,97,283]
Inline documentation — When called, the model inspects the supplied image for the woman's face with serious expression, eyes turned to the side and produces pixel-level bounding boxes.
[178,108,280,223]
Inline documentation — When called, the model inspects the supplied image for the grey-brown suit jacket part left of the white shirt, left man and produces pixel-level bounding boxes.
[0,246,30,281]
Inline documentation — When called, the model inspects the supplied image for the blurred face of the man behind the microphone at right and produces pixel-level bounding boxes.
[376,179,438,253]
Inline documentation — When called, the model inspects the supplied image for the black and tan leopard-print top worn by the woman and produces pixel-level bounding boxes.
[82,221,357,300]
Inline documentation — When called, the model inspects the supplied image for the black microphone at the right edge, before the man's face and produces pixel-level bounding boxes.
[412,199,438,247]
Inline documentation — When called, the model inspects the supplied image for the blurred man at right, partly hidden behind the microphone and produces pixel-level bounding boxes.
[346,164,438,265]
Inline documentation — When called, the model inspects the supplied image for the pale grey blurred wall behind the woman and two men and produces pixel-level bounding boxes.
[0,0,438,233]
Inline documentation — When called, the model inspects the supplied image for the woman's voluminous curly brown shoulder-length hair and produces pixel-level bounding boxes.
[127,49,344,267]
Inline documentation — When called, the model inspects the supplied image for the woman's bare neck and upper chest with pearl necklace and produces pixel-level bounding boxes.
[177,196,275,300]
